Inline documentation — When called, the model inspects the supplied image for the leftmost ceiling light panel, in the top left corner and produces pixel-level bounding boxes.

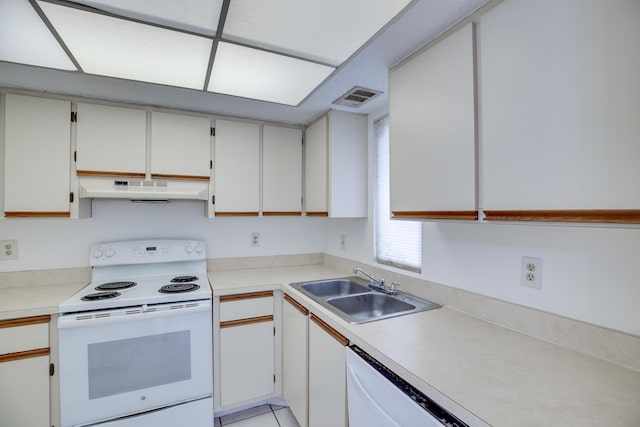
[0,0,76,70]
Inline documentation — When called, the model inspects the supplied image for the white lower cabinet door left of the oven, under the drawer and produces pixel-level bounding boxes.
[0,356,51,427]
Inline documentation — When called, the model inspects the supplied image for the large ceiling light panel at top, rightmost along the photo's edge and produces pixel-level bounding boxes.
[223,0,411,65]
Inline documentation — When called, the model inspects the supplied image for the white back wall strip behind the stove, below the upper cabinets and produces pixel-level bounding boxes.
[0,200,327,271]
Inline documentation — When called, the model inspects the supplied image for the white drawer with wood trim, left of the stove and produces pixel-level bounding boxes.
[0,316,50,354]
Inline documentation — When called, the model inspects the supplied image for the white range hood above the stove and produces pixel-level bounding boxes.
[78,177,209,201]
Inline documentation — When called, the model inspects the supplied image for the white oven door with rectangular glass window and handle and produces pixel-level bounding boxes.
[58,300,213,427]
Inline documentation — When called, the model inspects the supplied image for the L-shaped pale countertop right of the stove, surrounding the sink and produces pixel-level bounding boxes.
[209,265,640,427]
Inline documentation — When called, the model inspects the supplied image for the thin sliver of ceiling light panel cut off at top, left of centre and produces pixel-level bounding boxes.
[67,0,222,36]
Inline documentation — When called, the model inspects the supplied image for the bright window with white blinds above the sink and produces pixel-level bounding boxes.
[373,116,422,273]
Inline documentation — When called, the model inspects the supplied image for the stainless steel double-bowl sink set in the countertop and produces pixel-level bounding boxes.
[291,276,440,323]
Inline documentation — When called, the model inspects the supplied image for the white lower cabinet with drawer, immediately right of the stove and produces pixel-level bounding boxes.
[214,291,276,411]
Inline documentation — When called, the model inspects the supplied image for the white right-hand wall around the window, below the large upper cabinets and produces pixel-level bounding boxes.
[325,113,640,336]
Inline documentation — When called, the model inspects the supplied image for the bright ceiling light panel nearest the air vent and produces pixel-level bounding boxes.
[208,42,334,105]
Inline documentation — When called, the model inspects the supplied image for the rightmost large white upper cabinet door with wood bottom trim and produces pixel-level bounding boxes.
[479,0,640,222]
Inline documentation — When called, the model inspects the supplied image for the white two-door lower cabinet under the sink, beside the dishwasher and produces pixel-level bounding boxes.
[282,295,349,427]
